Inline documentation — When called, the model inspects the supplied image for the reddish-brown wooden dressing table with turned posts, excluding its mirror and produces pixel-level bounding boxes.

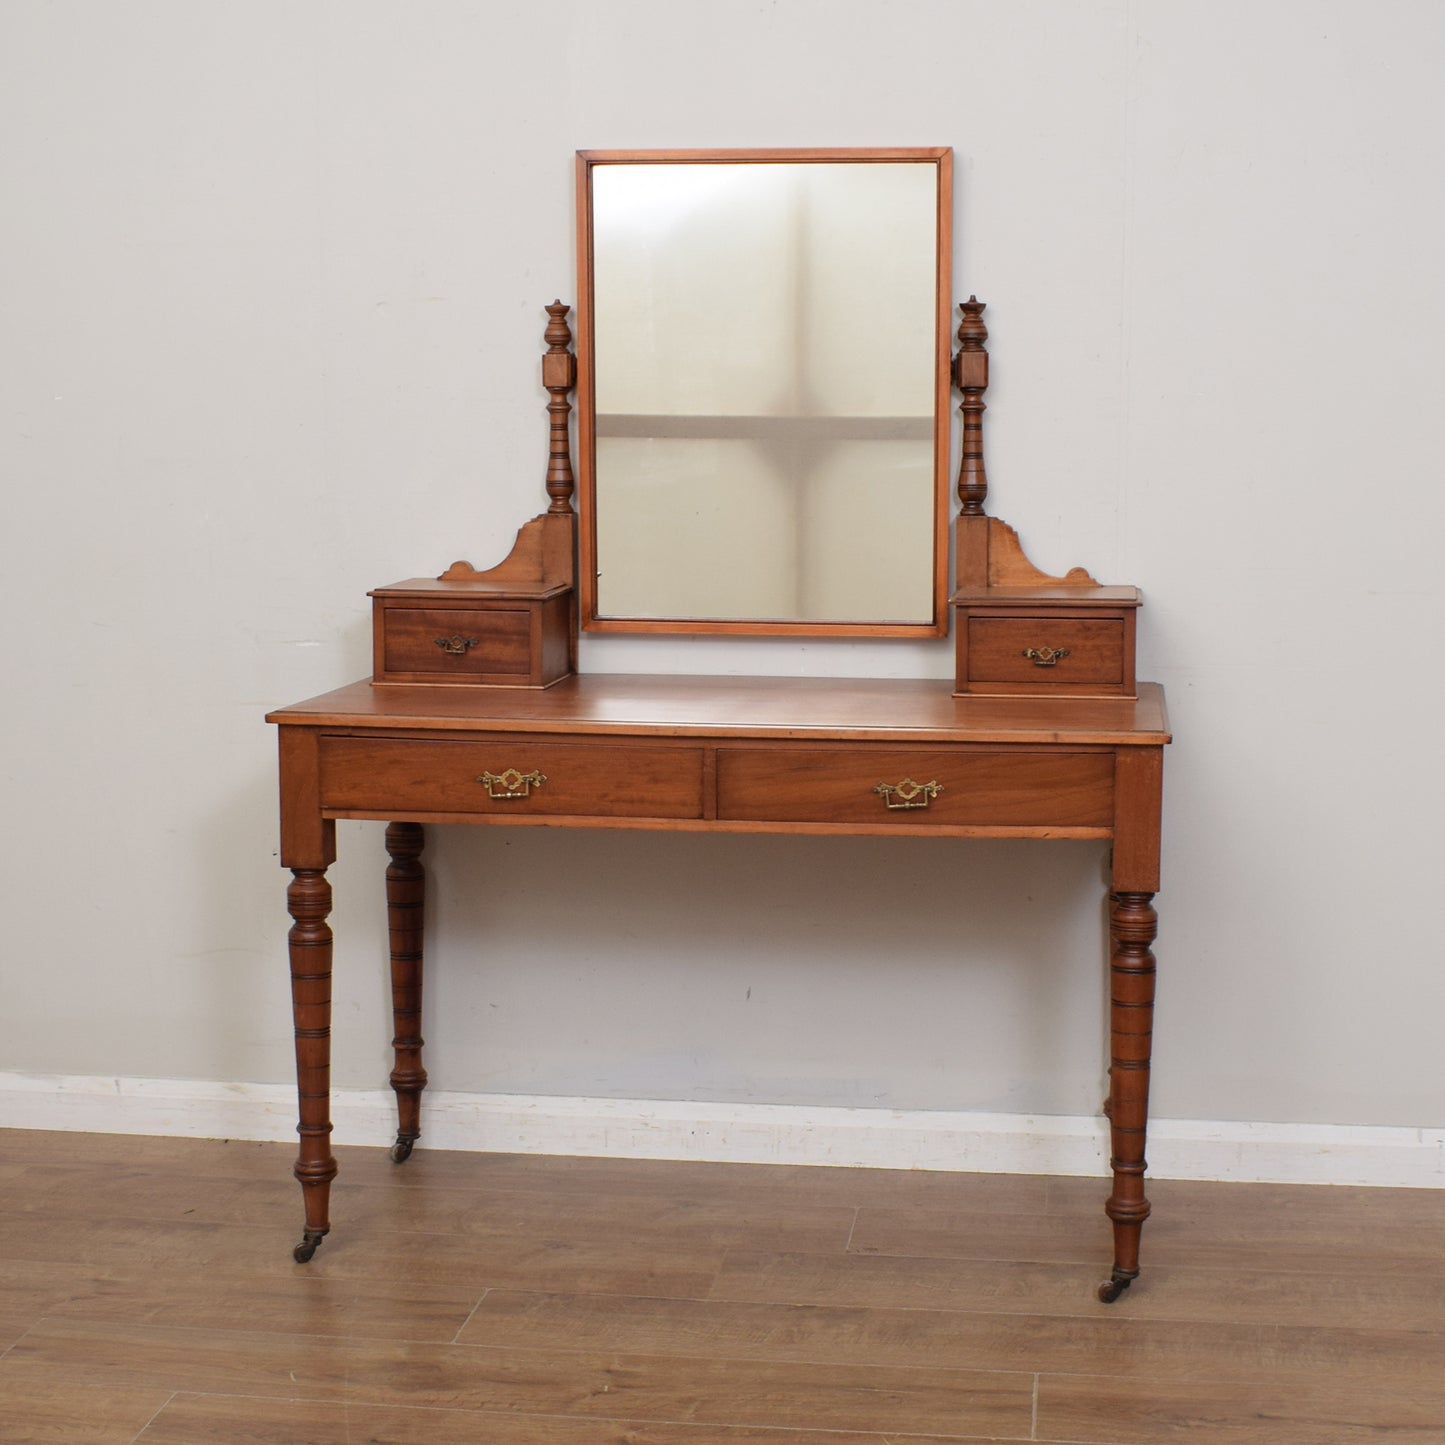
[267,150,1169,1302]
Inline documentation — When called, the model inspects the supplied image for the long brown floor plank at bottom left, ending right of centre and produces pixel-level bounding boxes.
[3,1319,1033,1435]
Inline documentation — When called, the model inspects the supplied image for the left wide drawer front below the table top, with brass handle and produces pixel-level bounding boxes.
[321,737,702,818]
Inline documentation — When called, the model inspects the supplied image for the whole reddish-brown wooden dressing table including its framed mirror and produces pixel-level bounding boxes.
[269,149,1169,1302]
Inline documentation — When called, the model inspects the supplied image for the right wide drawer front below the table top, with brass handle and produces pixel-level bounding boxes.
[718,747,1114,828]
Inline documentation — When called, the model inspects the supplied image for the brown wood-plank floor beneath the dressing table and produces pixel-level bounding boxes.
[0,1130,1445,1445]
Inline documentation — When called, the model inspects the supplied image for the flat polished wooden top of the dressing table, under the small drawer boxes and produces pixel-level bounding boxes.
[266,673,1170,747]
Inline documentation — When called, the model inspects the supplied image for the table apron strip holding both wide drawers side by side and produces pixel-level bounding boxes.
[315,733,1118,838]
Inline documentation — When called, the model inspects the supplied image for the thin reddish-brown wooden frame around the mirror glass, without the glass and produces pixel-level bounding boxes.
[575,146,954,639]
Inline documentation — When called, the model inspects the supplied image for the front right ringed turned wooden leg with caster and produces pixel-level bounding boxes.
[1098,893,1157,1305]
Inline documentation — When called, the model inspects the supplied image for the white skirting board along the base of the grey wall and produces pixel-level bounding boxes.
[0,1072,1445,1188]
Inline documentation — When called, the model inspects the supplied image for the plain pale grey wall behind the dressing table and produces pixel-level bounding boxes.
[0,0,1445,1126]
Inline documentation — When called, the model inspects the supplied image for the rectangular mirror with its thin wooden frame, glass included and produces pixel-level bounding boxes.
[577,147,952,636]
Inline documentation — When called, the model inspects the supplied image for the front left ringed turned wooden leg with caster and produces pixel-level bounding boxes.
[286,868,337,1264]
